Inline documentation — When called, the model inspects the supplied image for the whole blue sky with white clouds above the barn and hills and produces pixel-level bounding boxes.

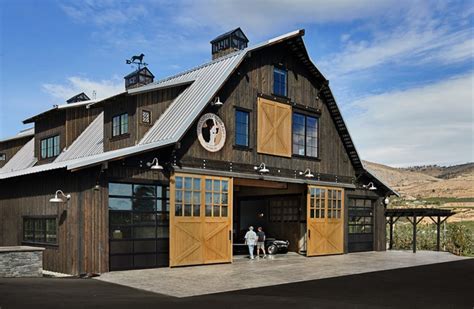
[0,0,474,166]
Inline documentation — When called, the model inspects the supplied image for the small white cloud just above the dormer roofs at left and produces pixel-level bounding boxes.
[42,76,125,100]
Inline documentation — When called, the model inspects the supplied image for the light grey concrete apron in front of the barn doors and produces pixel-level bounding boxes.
[96,251,465,297]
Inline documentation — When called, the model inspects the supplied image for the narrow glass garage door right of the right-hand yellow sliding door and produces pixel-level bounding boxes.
[348,198,374,252]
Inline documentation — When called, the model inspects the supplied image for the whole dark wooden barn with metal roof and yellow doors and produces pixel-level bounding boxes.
[0,28,393,274]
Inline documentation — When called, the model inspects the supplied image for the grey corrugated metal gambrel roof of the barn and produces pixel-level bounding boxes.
[0,30,393,191]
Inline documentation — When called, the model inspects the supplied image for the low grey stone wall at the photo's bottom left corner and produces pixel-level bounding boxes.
[0,246,44,278]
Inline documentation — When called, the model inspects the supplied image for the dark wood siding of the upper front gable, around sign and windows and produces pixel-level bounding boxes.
[182,46,355,177]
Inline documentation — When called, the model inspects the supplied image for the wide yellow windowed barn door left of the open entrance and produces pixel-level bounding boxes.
[170,174,232,266]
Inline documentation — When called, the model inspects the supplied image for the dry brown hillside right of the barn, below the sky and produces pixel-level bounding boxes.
[364,161,474,199]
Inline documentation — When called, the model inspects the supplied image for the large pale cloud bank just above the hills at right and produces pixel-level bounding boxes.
[347,73,474,166]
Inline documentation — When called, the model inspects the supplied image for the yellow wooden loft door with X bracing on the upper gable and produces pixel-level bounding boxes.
[257,98,291,157]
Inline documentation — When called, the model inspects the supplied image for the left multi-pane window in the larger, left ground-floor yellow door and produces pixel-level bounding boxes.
[175,176,201,217]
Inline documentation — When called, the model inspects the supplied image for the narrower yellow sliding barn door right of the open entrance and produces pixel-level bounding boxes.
[306,186,344,256]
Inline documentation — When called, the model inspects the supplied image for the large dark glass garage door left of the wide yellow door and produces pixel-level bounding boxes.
[109,183,169,270]
